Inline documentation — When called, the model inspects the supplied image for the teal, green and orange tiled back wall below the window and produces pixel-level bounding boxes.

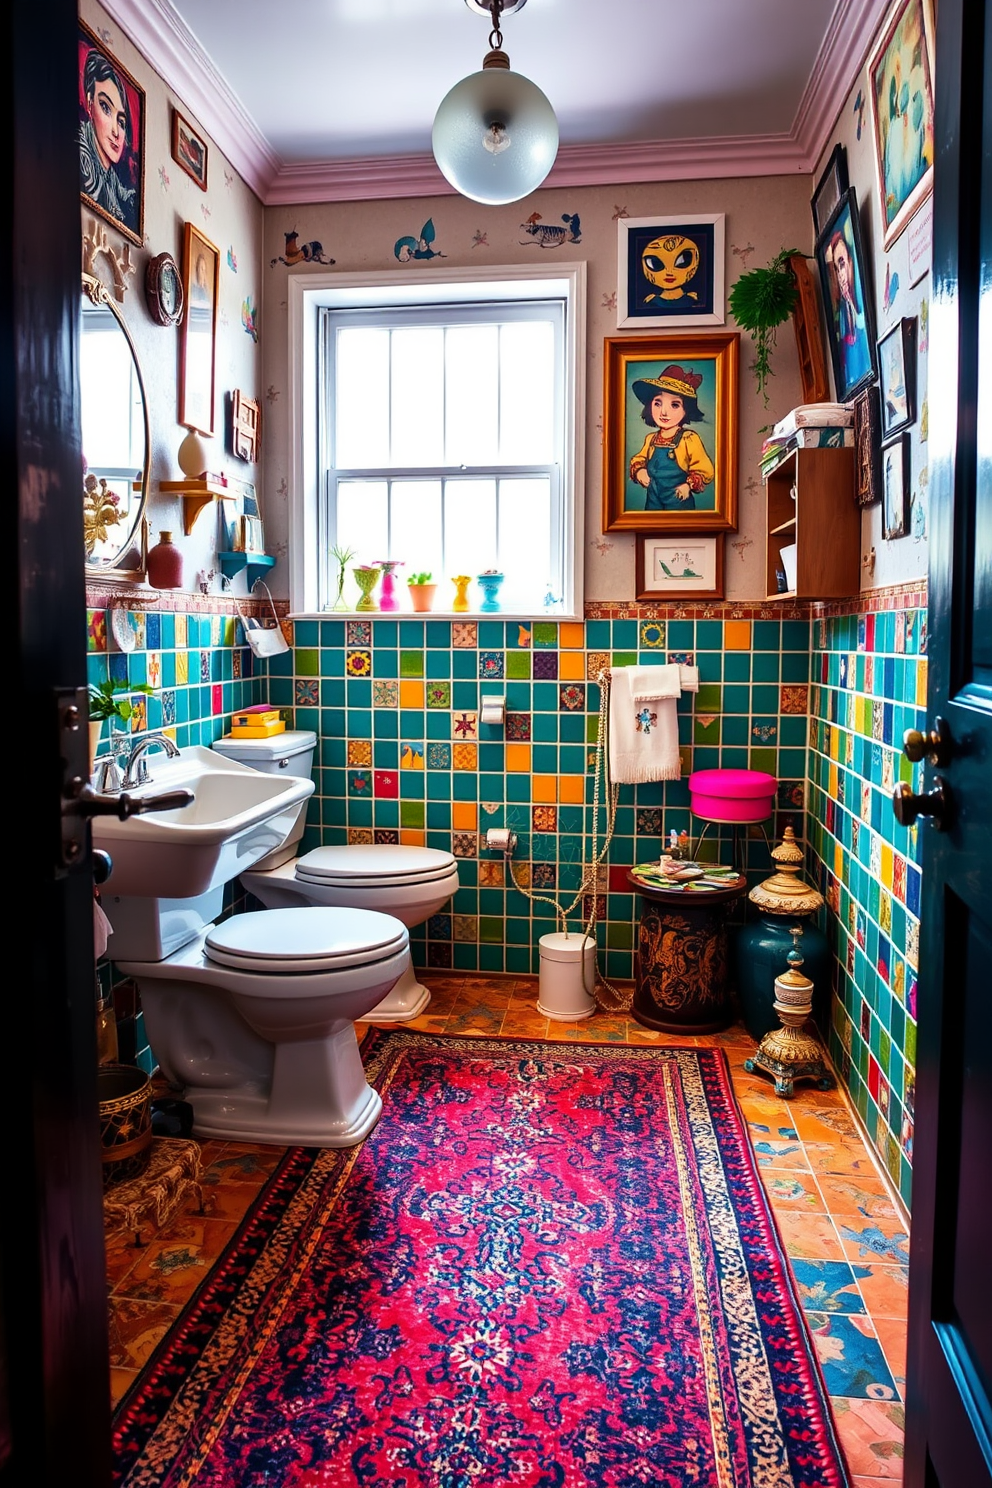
[269,604,809,978]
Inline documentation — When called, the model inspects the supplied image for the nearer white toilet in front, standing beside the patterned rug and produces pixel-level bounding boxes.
[112,908,410,1147]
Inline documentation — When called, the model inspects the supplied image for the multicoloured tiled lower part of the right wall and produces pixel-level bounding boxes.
[808,582,928,1205]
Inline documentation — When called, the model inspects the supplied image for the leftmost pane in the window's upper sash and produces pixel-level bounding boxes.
[333,326,390,470]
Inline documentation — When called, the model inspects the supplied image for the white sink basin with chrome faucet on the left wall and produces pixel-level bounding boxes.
[92,745,314,899]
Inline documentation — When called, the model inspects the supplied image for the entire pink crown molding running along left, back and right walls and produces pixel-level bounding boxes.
[103,0,889,207]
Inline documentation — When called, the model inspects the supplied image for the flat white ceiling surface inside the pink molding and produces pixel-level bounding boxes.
[173,0,834,164]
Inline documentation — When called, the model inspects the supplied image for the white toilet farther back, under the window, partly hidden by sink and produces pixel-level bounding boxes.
[213,729,458,1022]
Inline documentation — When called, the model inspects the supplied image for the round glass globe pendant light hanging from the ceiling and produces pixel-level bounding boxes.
[431,0,558,207]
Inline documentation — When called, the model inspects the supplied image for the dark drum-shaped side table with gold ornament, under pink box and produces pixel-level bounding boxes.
[628,873,747,1034]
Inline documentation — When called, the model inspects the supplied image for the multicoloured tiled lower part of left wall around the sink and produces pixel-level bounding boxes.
[86,591,266,1073]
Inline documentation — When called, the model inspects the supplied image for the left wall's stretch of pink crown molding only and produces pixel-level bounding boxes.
[103,0,280,202]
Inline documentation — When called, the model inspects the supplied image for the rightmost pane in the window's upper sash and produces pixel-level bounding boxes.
[500,320,555,464]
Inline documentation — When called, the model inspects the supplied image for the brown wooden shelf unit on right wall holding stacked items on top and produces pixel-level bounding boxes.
[764,449,861,600]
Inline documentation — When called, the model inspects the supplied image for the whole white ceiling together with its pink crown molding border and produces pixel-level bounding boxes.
[103,0,889,204]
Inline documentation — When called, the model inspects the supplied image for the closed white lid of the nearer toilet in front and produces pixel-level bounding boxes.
[204,906,409,975]
